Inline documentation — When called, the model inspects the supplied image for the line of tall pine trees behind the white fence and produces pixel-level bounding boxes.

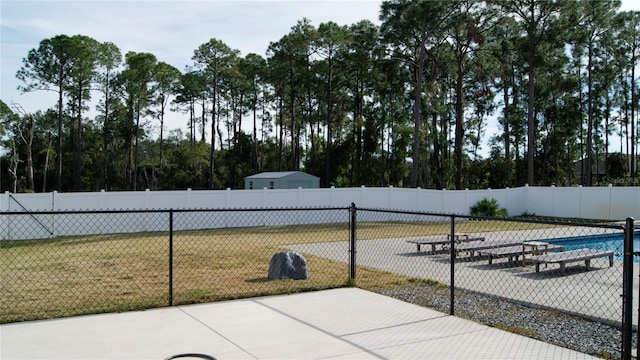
[0,0,640,192]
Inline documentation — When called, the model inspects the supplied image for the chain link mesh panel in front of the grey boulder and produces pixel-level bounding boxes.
[173,209,349,304]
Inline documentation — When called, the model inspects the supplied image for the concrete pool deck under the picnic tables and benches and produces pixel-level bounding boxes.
[289,228,640,325]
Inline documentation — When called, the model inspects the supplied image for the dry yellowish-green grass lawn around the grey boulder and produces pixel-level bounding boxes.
[0,221,549,323]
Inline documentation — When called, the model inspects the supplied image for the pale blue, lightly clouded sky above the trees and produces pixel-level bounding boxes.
[0,0,640,156]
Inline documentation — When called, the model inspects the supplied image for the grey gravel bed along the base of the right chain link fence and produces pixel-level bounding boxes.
[378,284,637,359]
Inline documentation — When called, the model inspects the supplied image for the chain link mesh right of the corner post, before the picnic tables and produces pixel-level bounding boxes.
[348,209,637,323]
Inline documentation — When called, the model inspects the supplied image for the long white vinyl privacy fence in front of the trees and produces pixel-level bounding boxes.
[0,186,640,240]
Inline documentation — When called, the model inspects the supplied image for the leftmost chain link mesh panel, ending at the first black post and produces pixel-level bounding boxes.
[0,213,168,322]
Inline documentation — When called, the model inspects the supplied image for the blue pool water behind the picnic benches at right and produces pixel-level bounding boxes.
[549,232,640,262]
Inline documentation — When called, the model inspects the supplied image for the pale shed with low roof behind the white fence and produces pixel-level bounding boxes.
[244,171,320,189]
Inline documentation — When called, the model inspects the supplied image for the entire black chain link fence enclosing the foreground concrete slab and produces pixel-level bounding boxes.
[0,206,638,358]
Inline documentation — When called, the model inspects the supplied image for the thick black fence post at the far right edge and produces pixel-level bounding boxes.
[622,218,634,360]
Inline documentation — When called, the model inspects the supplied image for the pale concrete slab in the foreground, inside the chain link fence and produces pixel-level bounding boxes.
[0,288,592,360]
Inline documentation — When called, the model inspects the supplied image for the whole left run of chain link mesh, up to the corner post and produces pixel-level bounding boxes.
[0,208,349,323]
